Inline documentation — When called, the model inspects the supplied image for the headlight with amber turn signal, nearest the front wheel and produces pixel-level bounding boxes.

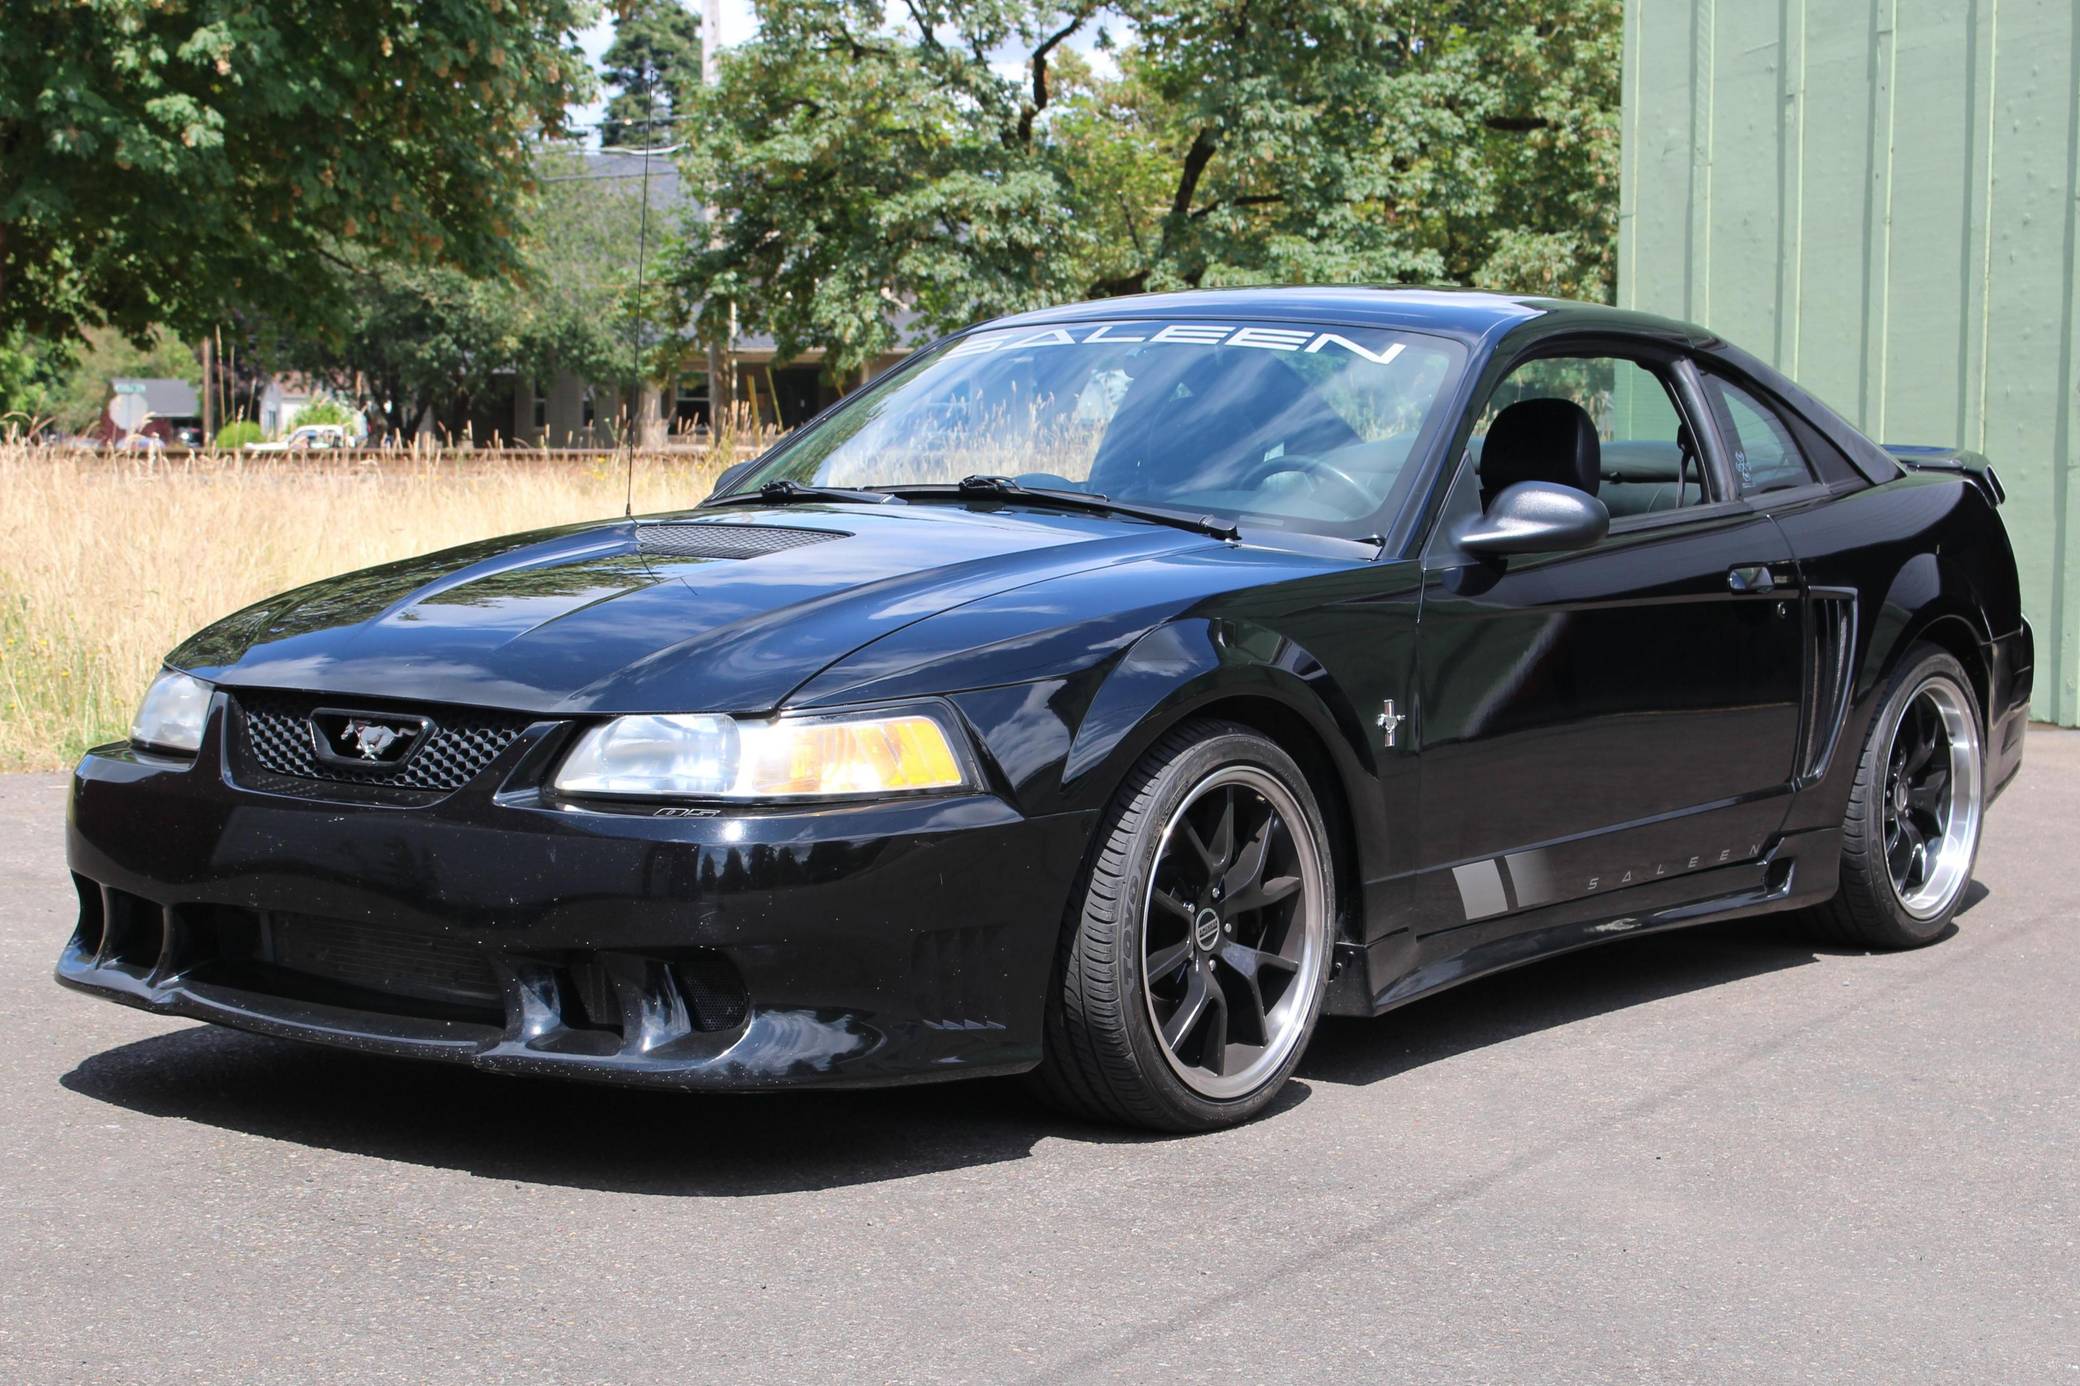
[555,710,973,799]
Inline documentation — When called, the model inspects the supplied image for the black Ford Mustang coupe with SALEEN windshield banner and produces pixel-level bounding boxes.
[56,287,2034,1132]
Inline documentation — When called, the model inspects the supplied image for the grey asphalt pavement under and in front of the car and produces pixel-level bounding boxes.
[0,728,2080,1386]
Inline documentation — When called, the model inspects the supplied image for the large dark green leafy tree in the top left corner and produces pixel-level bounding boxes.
[0,0,591,339]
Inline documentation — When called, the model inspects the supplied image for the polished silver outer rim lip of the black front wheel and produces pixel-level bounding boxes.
[1134,766,1329,1101]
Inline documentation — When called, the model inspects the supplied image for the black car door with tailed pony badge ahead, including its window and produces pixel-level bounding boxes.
[1414,350,1803,945]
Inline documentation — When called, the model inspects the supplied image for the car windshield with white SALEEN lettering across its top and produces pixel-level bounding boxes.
[732,320,1462,535]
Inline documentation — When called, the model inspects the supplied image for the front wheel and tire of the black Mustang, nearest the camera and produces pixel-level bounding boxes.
[1034,720,1335,1132]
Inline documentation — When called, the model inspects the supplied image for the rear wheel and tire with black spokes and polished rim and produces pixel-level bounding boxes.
[1805,645,1986,949]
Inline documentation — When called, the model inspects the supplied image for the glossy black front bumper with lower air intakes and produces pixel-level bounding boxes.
[56,695,1092,1088]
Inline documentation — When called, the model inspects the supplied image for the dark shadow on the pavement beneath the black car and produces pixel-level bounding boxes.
[60,884,1984,1197]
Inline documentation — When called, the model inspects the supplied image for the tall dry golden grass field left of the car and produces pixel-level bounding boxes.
[0,443,744,770]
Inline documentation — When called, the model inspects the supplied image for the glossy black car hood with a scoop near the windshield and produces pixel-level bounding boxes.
[168,502,1217,712]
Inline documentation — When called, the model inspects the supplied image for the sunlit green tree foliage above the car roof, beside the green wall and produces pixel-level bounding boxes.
[672,0,1622,370]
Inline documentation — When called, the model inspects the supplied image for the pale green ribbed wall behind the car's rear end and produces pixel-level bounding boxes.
[1618,0,2080,724]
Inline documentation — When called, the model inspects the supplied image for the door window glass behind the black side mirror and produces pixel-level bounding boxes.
[1473,356,1710,522]
